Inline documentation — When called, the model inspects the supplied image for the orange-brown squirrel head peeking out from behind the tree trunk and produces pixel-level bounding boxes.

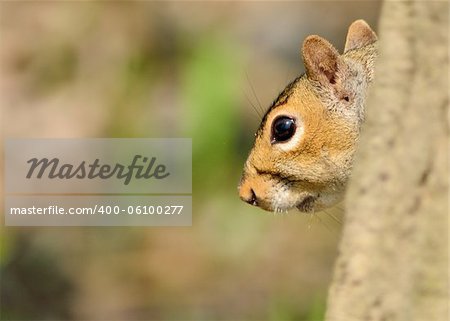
[238,20,377,213]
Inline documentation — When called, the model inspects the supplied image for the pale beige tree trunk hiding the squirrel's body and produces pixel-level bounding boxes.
[326,0,449,321]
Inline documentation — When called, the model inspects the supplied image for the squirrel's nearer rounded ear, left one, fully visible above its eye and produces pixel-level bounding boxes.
[302,36,339,85]
